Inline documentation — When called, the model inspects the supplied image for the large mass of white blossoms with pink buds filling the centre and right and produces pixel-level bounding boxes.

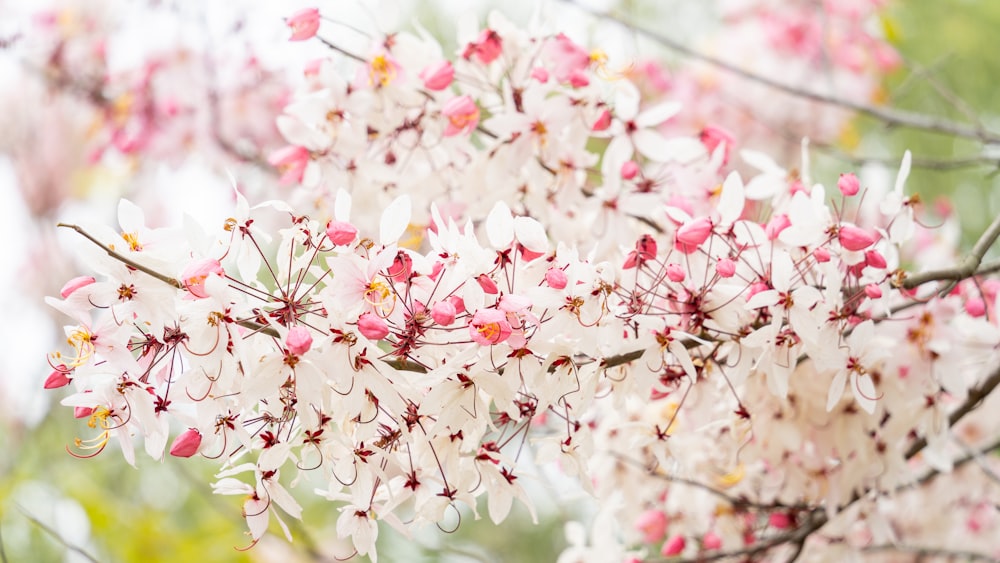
[46,2,1000,561]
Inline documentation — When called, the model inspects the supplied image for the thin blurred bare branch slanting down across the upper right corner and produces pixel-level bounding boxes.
[566,0,1000,143]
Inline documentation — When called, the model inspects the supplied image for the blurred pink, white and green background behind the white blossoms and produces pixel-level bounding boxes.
[0,0,1000,562]
